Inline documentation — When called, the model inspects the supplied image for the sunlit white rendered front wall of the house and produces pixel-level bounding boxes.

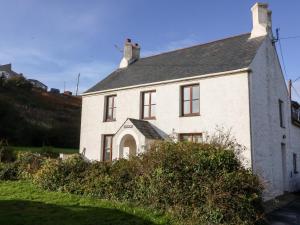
[80,72,251,167]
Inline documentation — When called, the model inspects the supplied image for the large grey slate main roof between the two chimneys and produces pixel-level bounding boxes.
[85,33,264,93]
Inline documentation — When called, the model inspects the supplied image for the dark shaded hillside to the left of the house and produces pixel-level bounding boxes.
[0,76,81,148]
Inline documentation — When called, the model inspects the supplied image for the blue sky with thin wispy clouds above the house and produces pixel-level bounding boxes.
[0,0,300,97]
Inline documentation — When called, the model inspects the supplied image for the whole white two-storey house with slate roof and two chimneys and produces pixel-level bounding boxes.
[80,3,300,198]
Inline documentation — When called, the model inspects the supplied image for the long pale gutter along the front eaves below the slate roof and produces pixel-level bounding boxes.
[80,67,251,96]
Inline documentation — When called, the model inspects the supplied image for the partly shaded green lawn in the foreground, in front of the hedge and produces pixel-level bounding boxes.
[0,181,171,225]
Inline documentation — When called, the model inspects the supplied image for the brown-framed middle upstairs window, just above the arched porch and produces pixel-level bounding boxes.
[142,91,156,119]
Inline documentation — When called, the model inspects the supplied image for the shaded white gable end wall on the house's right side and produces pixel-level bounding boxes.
[250,38,300,199]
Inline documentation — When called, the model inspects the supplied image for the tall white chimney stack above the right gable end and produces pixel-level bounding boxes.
[250,3,272,38]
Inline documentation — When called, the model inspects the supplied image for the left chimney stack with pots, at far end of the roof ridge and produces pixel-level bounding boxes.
[119,38,141,68]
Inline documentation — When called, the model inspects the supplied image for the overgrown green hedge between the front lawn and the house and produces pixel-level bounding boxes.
[34,142,263,225]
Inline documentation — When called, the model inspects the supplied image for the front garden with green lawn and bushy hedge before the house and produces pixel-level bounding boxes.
[0,136,264,225]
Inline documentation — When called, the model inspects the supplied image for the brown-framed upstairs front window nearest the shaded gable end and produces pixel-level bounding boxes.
[181,84,200,116]
